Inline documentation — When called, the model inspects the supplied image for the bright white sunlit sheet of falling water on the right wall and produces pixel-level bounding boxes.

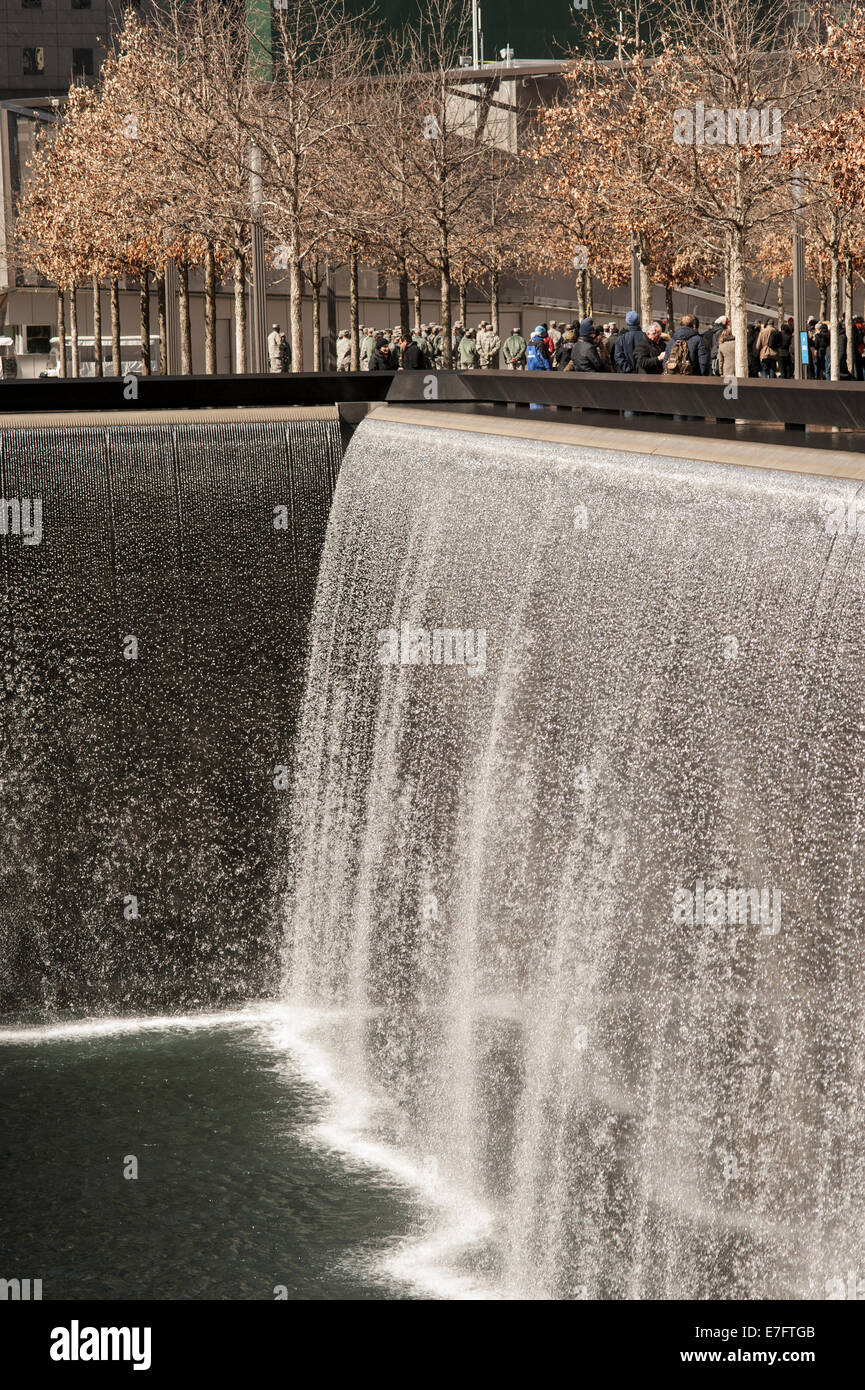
[284,420,865,1298]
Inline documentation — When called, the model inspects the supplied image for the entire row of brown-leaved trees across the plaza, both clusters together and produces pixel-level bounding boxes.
[17,0,865,375]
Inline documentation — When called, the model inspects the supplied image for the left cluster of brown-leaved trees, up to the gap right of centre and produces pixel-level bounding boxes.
[17,0,517,373]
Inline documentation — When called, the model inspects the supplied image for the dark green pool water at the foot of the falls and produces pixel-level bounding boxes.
[0,1024,420,1301]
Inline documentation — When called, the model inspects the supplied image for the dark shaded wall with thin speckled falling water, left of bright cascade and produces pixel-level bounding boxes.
[0,405,342,1017]
